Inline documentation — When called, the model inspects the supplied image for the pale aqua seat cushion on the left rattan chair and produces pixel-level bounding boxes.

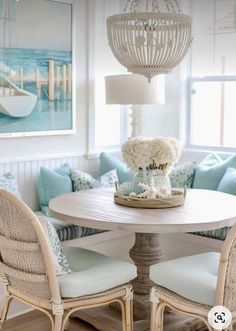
[58,247,137,298]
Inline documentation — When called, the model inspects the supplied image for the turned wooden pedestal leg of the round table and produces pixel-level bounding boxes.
[130,233,164,319]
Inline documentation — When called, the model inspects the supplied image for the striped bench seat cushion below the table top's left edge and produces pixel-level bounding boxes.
[35,211,104,241]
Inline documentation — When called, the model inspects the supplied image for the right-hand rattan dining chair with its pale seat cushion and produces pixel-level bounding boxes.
[150,220,236,331]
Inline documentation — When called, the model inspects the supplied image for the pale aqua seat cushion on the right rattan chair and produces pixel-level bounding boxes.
[150,252,220,306]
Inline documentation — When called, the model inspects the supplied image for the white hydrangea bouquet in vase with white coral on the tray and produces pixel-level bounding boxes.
[120,137,181,199]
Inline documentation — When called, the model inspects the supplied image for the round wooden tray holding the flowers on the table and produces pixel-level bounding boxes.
[114,189,186,209]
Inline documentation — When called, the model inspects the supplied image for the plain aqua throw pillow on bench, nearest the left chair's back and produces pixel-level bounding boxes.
[37,164,72,210]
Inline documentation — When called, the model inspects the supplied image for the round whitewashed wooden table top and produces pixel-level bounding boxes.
[49,188,236,233]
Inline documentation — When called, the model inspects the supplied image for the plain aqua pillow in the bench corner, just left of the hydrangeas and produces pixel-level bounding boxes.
[99,153,134,183]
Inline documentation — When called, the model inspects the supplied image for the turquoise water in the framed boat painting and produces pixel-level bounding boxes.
[0,48,72,133]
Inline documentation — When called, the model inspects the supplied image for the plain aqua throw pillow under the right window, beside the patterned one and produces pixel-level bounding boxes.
[193,154,236,190]
